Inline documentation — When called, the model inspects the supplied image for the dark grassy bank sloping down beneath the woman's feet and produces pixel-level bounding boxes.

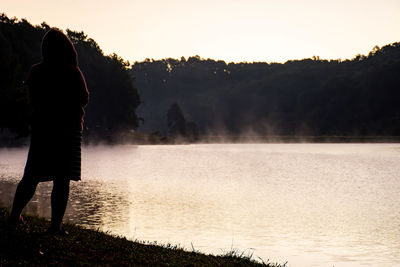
[0,208,285,267]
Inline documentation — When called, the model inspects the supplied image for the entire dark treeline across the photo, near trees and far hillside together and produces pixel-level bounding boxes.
[0,14,400,143]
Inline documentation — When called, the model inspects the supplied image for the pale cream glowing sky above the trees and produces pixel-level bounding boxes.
[0,0,400,63]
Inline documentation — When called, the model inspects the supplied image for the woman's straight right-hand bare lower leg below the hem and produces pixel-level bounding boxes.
[51,179,69,230]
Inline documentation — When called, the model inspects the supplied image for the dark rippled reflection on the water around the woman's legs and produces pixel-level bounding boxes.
[0,179,130,234]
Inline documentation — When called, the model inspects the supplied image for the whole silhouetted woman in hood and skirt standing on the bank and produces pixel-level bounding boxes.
[9,29,89,234]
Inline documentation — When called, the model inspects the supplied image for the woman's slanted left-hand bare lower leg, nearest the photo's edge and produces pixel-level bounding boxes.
[9,176,38,225]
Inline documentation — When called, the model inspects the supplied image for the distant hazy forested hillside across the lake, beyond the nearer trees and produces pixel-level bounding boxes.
[131,43,400,136]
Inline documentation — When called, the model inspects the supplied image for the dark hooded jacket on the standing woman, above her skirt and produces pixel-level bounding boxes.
[27,29,89,132]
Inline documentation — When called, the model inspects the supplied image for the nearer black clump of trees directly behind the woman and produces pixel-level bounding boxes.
[0,14,140,143]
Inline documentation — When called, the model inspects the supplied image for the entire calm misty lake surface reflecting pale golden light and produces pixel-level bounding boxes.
[0,144,400,266]
